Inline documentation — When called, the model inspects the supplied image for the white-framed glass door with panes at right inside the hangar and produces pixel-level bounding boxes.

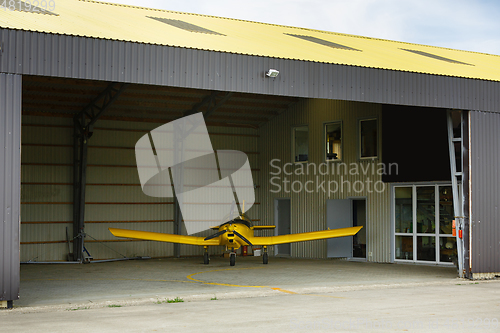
[393,185,457,263]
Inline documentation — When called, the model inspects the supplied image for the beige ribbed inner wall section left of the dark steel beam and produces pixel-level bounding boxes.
[21,116,73,261]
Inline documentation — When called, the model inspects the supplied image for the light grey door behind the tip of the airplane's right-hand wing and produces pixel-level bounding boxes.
[326,199,352,258]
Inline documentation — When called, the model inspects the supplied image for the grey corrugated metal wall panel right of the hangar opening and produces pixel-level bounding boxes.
[470,111,500,273]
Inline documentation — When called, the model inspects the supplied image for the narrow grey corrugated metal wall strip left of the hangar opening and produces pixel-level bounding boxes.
[0,73,22,301]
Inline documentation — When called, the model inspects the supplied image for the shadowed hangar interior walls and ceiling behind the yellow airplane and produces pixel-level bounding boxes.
[20,72,462,264]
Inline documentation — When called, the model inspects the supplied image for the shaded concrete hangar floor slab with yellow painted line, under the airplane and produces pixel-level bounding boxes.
[14,257,460,312]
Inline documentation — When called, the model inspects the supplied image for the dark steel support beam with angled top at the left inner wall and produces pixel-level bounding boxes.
[70,82,128,262]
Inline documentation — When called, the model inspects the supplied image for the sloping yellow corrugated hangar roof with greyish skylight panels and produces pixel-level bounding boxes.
[0,0,500,81]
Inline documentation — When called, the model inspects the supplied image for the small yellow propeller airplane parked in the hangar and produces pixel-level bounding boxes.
[109,214,362,266]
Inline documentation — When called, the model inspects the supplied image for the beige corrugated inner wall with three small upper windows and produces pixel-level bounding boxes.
[260,99,391,262]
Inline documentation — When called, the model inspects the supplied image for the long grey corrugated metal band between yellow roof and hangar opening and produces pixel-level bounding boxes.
[0,29,500,112]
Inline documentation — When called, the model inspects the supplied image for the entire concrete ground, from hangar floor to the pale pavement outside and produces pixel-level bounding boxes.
[0,257,500,332]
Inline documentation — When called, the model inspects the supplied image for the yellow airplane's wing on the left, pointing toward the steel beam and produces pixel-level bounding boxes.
[109,228,220,245]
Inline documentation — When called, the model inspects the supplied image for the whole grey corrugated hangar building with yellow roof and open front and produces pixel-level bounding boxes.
[0,0,500,302]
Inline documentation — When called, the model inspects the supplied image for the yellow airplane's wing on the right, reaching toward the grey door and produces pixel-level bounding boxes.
[248,227,363,245]
